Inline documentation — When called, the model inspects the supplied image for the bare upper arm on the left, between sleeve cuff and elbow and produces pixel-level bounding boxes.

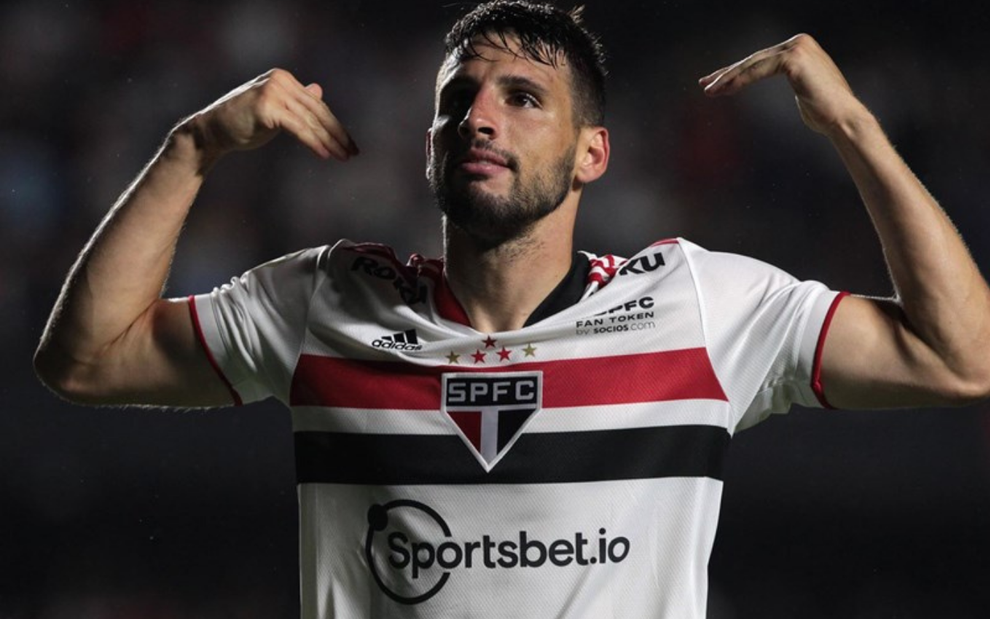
[67,299,232,407]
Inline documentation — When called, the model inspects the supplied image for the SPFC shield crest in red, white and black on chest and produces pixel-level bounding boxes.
[440,372,543,471]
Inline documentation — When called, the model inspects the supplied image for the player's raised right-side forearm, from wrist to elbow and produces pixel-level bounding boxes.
[828,108,990,377]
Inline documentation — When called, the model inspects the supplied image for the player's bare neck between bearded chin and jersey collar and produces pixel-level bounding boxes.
[444,204,577,333]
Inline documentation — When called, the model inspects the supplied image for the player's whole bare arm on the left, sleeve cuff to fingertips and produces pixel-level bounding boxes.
[35,69,357,406]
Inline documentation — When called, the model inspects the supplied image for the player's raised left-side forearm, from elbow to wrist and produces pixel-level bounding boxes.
[38,123,209,370]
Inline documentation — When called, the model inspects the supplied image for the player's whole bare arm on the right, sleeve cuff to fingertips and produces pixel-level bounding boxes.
[700,34,990,408]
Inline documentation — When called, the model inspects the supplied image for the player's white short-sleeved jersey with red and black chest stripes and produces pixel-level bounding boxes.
[190,239,841,619]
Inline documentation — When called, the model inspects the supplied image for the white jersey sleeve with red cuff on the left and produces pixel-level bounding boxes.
[189,247,328,404]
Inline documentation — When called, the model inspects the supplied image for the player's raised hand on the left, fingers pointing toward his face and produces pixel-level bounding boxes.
[180,69,358,162]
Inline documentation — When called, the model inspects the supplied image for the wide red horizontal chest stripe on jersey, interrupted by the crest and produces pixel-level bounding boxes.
[289,348,728,410]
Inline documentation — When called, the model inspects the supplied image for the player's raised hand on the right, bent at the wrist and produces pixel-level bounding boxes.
[698,34,865,135]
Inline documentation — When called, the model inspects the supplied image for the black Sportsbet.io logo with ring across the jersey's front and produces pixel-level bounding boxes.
[364,499,632,604]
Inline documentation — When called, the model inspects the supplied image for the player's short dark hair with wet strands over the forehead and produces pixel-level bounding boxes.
[444,0,606,126]
